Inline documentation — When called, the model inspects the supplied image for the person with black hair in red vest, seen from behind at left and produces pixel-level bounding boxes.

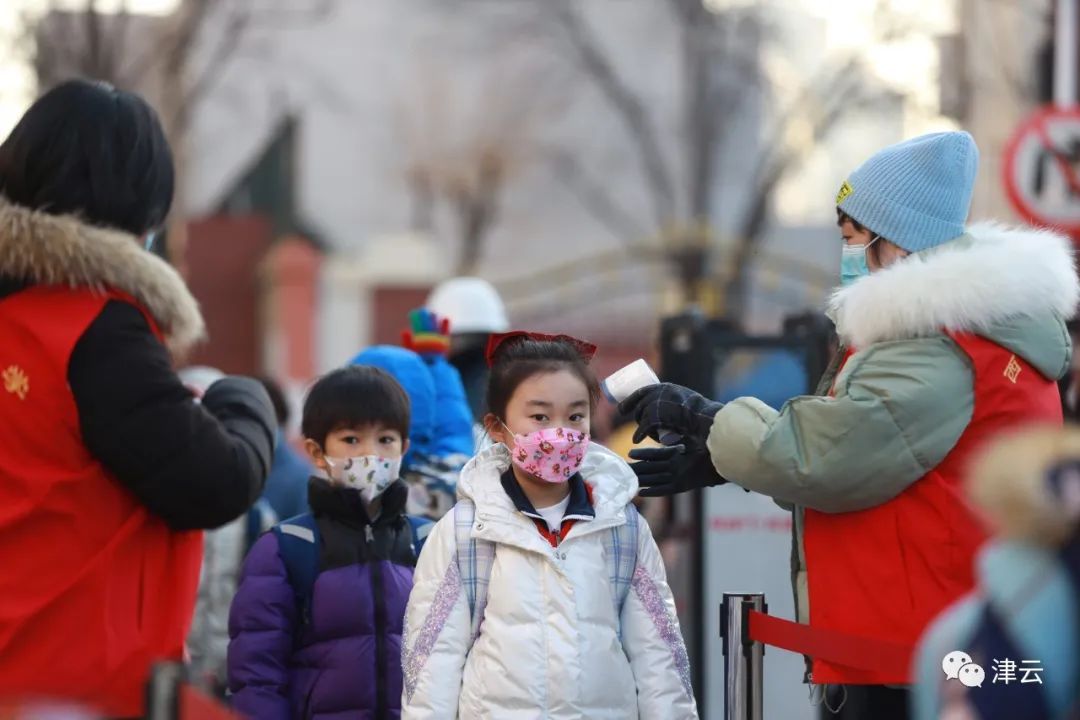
[0,80,274,717]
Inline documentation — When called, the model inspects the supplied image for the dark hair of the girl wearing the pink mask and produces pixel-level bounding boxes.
[487,337,600,420]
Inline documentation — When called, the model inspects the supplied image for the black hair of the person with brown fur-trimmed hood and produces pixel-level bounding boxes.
[0,80,174,235]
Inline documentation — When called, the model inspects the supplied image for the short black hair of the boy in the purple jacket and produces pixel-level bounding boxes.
[301,365,410,447]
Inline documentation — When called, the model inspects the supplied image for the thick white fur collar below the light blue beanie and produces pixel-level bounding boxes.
[828,222,1080,348]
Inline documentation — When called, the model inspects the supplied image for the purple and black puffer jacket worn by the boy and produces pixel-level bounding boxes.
[228,479,415,720]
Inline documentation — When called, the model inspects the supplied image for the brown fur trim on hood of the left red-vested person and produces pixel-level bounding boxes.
[0,198,206,354]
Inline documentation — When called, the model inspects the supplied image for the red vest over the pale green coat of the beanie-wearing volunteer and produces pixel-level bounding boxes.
[804,334,1062,684]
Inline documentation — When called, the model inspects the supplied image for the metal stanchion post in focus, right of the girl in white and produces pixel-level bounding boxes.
[720,593,766,720]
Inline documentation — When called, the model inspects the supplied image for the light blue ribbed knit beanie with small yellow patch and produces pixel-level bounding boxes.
[836,133,978,253]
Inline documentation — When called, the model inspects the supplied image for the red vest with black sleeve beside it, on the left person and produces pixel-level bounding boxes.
[0,287,202,716]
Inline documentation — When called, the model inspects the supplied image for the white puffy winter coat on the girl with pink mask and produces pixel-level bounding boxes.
[402,445,697,720]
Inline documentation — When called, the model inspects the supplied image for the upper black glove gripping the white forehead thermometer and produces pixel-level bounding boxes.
[619,382,724,446]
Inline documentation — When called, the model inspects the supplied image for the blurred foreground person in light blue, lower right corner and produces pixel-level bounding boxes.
[913,425,1080,720]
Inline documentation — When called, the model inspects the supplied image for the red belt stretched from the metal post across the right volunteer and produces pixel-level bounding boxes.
[748,610,915,682]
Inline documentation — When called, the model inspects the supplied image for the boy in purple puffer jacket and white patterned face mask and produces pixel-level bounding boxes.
[229,366,430,718]
